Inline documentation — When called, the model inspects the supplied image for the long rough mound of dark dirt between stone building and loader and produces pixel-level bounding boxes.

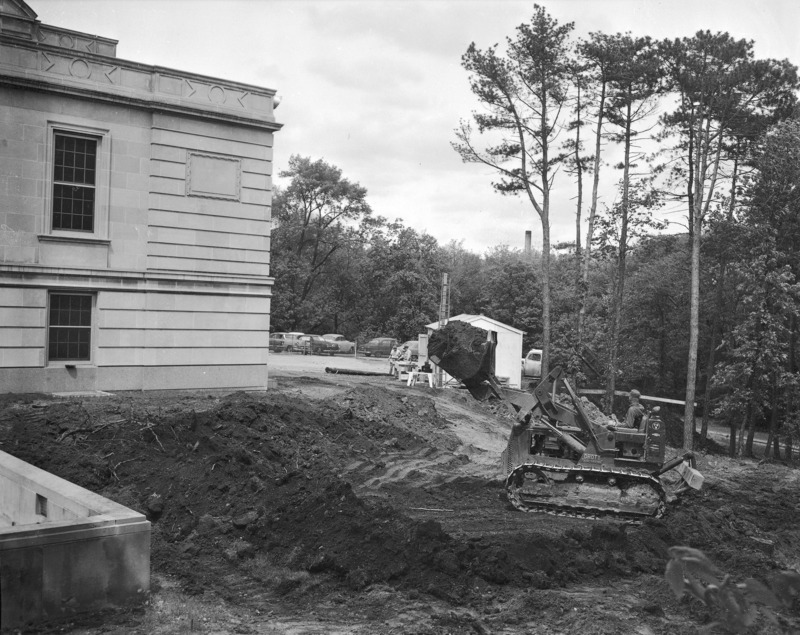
[4,387,556,597]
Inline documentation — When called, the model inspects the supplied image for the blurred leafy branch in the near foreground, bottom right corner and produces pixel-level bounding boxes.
[664,547,800,633]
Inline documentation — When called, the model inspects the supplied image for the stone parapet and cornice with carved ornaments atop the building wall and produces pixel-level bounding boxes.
[0,35,282,130]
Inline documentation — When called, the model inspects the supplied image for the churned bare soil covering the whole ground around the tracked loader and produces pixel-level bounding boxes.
[0,375,800,635]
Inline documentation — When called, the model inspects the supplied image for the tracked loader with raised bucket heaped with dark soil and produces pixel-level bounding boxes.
[428,321,703,523]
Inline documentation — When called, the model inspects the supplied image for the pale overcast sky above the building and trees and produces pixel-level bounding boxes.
[32,0,800,254]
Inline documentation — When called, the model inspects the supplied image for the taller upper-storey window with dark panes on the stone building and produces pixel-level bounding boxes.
[53,133,97,232]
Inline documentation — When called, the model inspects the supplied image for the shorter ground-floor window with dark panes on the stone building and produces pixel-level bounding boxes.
[47,293,92,362]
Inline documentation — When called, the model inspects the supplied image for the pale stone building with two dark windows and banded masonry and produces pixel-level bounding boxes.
[0,0,281,392]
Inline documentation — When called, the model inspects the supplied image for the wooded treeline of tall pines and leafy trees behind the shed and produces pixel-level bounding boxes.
[271,6,800,462]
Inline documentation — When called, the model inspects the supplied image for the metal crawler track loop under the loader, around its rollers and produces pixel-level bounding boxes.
[506,462,667,525]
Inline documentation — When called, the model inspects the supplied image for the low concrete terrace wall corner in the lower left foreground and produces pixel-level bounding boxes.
[0,452,150,631]
